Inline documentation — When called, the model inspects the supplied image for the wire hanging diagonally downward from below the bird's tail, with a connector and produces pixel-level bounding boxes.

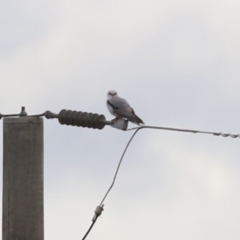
[82,127,142,240]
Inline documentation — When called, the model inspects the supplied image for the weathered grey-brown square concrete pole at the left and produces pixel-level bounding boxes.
[2,117,44,240]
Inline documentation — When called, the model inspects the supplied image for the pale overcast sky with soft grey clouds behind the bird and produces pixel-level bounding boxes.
[0,0,240,240]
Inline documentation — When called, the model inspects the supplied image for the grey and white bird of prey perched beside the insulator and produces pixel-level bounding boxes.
[107,90,144,125]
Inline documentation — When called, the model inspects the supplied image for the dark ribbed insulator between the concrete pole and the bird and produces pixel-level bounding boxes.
[58,109,106,129]
